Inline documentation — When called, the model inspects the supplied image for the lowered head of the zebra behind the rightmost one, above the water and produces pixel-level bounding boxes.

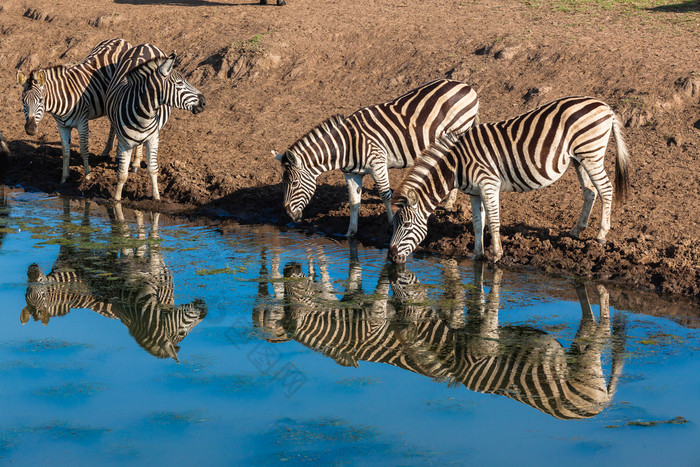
[275,150,318,222]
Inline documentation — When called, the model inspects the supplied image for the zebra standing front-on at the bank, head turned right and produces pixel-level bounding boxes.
[107,44,206,201]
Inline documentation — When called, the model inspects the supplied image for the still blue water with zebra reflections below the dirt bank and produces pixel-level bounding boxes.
[0,190,700,465]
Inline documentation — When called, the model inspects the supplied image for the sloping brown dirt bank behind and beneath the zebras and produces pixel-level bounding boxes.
[0,0,700,298]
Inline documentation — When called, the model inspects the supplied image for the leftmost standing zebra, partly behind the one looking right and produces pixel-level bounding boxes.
[17,39,131,183]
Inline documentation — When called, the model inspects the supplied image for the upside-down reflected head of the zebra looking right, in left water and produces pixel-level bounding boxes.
[141,299,207,363]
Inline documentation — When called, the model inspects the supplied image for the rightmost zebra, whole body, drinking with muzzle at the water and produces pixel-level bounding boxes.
[389,97,629,263]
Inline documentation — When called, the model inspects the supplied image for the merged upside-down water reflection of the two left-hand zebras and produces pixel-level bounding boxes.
[21,201,207,361]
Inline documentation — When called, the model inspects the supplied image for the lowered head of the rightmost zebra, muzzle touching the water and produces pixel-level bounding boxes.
[389,188,428,263]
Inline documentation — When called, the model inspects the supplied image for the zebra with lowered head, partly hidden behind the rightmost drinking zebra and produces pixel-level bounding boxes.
[273,79,479,237]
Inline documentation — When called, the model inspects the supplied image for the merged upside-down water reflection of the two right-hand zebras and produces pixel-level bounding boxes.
[254,249,624,419]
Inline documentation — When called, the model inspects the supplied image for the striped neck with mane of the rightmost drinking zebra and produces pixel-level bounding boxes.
[391,132,459,211]
